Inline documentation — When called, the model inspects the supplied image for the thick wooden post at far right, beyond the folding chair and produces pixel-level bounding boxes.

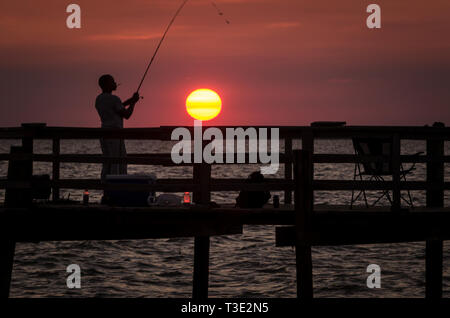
[425,135,444,299]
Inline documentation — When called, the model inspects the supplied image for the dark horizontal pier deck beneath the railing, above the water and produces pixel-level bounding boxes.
[0,204,450,246]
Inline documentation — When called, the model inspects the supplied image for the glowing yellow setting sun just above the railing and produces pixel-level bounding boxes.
[186,88,222,120]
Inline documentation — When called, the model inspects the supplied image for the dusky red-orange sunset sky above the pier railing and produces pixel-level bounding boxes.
[0,0,450,127]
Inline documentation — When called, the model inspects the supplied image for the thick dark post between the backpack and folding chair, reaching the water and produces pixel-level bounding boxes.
[294,150,314,300]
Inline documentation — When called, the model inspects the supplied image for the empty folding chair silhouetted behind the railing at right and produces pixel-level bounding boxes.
[350,137,423,208]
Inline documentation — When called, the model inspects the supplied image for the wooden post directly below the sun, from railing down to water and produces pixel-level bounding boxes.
[192,163,211,299]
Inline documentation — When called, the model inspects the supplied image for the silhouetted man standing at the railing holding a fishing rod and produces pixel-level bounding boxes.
[95,74,139,180]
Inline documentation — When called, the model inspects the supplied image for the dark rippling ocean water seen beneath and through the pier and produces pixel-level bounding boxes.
[0,140,450,298]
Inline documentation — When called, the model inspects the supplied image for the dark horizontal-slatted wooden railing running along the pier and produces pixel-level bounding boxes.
[0,124,450,208]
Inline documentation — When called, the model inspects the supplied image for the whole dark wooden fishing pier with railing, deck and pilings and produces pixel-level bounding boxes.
[0,124,450,300]
